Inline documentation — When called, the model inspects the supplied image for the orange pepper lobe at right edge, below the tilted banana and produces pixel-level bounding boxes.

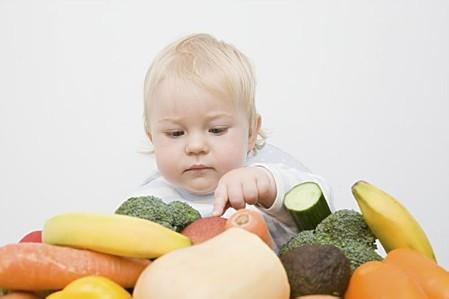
[384,248,449,299]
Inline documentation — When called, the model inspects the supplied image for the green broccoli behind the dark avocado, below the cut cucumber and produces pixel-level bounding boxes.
[279,210,382,270]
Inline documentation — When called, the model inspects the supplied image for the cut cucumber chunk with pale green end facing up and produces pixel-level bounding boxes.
[284,182,331,231]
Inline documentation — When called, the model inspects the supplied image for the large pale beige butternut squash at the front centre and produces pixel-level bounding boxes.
[133,228,290,299]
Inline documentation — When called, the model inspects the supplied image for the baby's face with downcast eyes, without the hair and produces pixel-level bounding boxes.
[150,80,254,195]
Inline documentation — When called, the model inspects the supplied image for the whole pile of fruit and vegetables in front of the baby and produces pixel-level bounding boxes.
[0,181,449,299]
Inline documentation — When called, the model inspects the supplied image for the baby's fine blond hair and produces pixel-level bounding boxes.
[144,33,265,150]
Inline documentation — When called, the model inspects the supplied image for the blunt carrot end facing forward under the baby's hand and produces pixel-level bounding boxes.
[225,209,273,248]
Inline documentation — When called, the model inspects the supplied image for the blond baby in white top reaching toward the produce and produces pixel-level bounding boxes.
[133,34,330,249]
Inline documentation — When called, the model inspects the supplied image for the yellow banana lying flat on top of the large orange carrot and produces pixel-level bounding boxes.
[42,213,191,258]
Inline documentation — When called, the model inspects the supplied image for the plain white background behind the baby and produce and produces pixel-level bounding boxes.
[0,0,449,269]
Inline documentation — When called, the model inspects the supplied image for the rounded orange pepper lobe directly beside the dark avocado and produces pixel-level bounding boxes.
[345,261,427,299]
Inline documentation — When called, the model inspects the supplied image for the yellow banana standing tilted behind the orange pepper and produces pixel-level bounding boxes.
[352,181,436,261]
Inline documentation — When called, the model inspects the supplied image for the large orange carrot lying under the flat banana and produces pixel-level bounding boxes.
[0,243,150,291]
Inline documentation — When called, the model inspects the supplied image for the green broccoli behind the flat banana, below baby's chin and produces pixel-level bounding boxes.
[115,196,201,232]
